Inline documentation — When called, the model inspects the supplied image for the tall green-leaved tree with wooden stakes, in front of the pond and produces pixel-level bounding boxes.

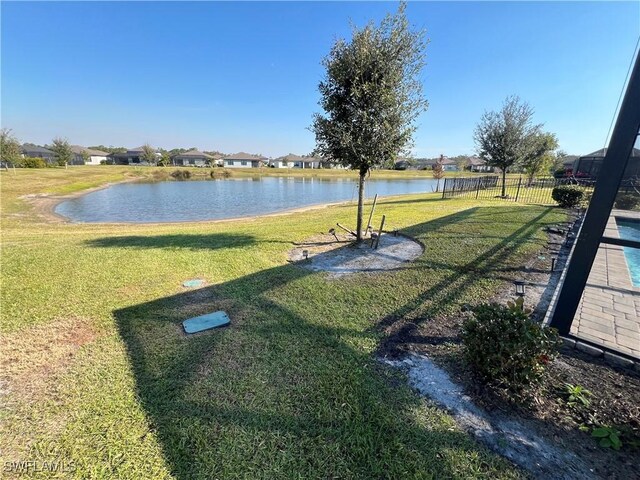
[311,3,427,241]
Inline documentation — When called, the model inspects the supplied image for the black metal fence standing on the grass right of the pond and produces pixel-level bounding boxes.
[442,175,595,205]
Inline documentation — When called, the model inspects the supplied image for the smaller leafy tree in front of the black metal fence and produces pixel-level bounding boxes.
[474,95,542,197]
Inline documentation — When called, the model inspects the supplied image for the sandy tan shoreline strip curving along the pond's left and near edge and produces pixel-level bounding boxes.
[18,178,436,226]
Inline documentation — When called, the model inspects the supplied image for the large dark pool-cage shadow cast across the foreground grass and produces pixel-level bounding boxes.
[109,209,556,479]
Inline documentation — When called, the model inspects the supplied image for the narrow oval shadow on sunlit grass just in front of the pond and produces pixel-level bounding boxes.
[86,233,264,250]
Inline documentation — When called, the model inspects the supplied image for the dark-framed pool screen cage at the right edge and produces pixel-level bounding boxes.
[549,50,640,358]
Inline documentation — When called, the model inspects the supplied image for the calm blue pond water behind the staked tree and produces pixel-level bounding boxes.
[55,177,436,223]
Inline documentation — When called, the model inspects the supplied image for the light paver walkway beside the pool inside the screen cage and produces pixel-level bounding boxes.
[571,212,640,359]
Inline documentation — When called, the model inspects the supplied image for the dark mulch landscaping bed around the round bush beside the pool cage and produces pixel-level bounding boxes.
[379,227,640,479]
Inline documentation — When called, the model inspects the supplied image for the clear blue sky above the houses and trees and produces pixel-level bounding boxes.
[1,1,640,156]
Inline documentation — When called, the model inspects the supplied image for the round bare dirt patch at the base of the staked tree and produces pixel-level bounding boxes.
[289,233,424,276]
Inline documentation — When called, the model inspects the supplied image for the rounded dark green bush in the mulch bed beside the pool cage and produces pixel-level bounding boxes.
[462,303,560,391]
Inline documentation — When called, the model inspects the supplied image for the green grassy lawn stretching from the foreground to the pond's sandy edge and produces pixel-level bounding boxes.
[0,167,565,479]
